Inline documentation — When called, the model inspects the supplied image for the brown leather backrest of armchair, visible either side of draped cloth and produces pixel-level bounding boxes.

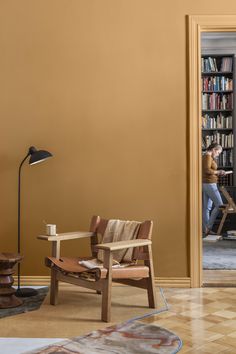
[90,216,153,260]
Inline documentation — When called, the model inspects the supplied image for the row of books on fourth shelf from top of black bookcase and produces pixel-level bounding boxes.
[202,113,233,129]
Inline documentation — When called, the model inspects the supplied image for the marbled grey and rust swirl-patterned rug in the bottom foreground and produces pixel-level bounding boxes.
[25,315,182,354]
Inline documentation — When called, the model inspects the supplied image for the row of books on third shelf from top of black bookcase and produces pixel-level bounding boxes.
[202,93,233,110]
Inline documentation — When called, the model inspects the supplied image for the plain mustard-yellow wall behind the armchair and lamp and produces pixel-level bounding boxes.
[0,0,232,277]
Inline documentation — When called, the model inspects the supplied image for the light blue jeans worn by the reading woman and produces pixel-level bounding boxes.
[202,183,223,232]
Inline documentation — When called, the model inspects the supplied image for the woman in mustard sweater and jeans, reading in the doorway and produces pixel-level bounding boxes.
[202,143,225,236]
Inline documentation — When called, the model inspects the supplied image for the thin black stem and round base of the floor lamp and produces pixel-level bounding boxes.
[15,151,38,297]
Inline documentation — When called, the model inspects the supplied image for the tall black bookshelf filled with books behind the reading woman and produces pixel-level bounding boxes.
[201,54,236,186]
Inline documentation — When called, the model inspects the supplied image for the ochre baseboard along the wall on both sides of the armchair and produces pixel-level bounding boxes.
[14,275,191,288]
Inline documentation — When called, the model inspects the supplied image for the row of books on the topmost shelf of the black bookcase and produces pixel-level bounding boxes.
[201,57,233,72]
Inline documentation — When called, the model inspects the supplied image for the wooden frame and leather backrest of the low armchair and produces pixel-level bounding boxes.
[38,216,157,322]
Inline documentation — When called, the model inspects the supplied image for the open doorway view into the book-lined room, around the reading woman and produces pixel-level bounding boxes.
[201,32,236,286]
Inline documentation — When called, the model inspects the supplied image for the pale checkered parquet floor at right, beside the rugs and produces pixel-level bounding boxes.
[143,288,236,354]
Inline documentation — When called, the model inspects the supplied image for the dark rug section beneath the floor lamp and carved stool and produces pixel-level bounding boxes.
[0,286,48,318]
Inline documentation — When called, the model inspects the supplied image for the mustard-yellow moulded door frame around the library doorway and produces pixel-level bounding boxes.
[188,15,236,287]
